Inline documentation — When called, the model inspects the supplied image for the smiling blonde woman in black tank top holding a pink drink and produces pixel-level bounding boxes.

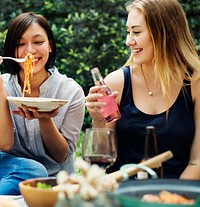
[86,0,200,179]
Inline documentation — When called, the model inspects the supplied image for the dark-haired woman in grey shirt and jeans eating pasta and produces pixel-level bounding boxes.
[0,12,85,194]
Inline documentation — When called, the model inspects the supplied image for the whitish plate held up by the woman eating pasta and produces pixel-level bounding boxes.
[7,96,68,112]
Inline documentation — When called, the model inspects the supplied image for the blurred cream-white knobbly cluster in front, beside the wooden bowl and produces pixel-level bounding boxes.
[53,159,118,201]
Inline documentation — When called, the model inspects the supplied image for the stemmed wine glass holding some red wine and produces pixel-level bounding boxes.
[82,128,117,170]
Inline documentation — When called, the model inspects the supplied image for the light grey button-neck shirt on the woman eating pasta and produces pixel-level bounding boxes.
[2,68,85,176]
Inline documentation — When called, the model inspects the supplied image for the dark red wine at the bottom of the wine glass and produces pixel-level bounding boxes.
[83,155,116,168]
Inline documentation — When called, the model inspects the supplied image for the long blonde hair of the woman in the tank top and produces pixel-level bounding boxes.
[125,0,200,98]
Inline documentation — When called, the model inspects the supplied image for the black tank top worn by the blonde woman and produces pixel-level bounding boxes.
[107,67,195,178]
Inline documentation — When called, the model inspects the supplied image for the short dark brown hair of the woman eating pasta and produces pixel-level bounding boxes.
[4,12,56,75]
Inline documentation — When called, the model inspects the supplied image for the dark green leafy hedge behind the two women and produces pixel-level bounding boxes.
[0,0,200,152]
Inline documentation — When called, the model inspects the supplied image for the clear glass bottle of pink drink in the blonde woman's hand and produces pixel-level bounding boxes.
[91,68,121,122]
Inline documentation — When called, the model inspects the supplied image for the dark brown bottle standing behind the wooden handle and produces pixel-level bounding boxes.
[138,126,162,179]
